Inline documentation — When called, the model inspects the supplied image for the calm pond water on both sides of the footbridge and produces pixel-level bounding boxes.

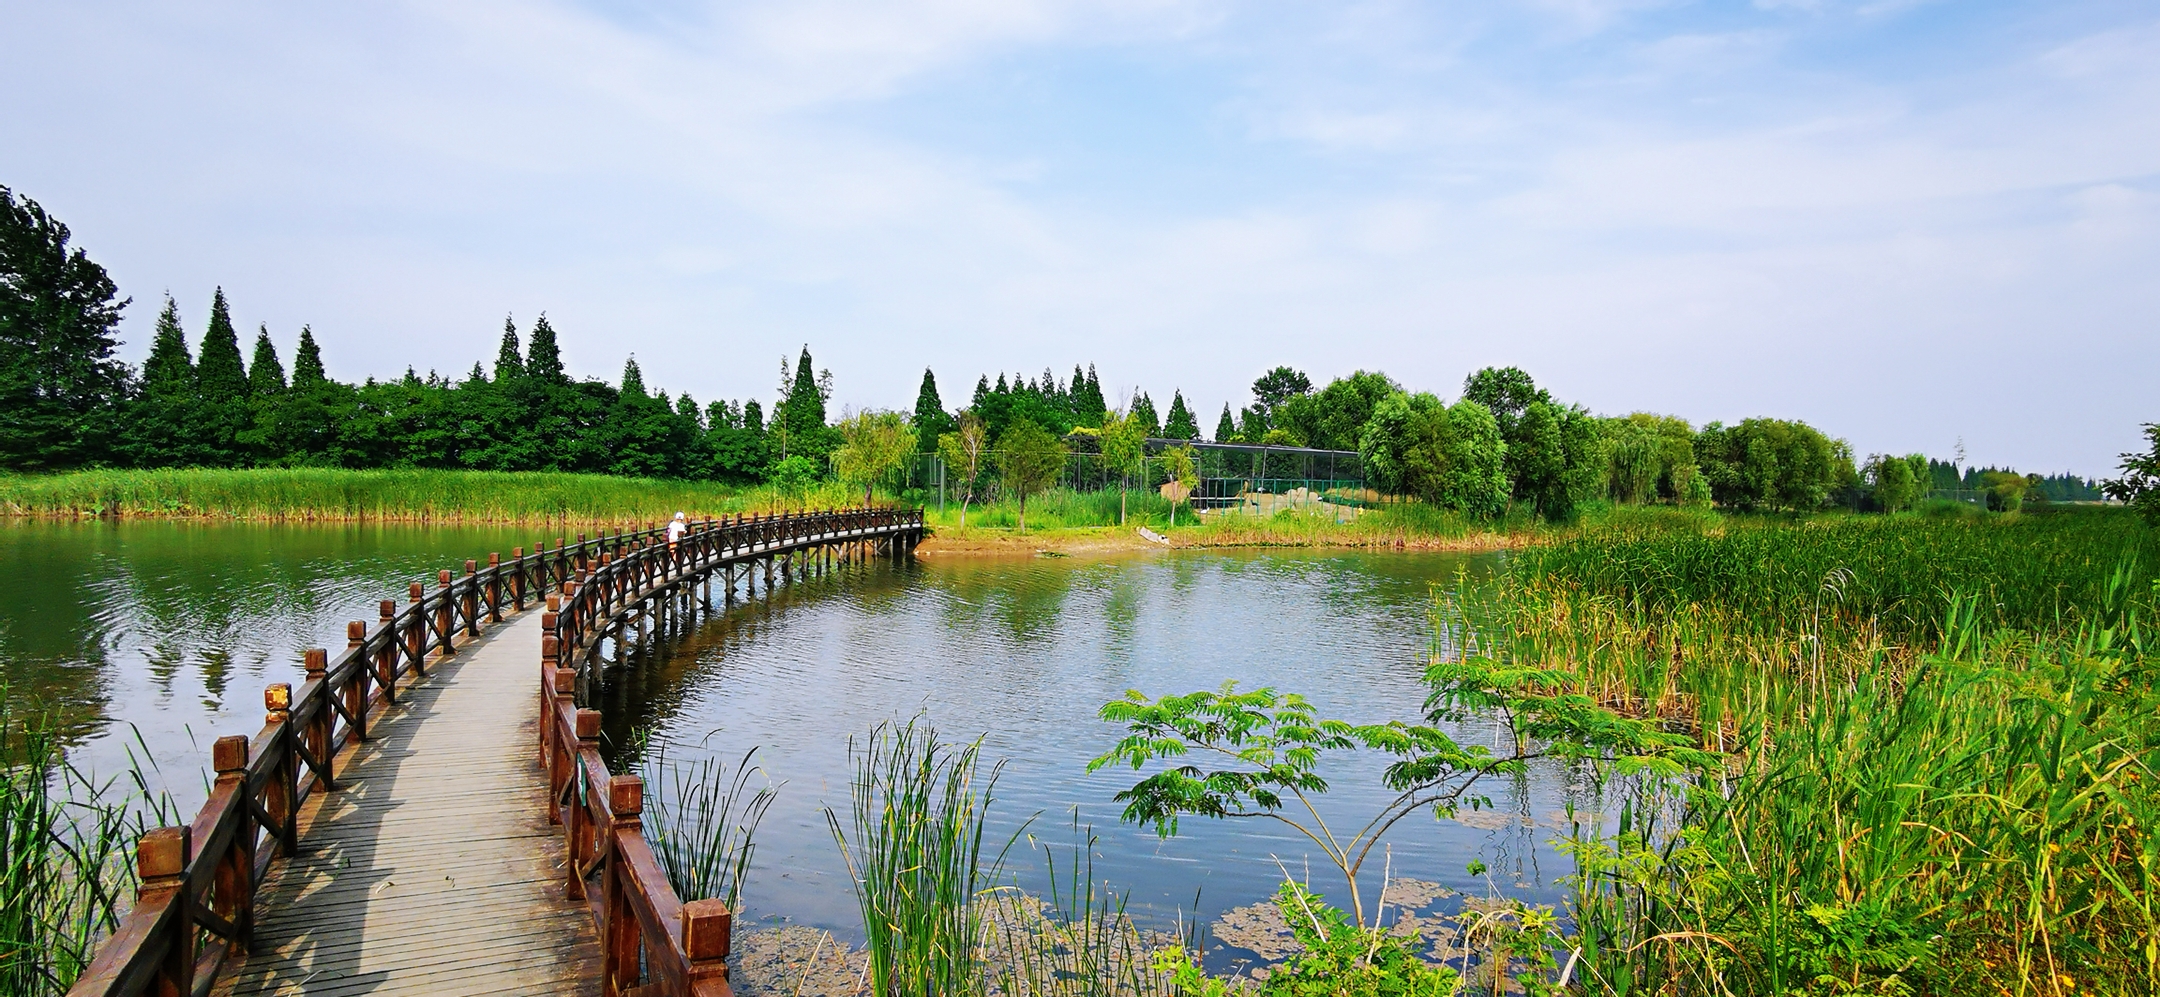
[0,520,1588,958]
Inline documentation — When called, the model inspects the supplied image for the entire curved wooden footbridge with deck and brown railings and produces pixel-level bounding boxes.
[69,509,922,997]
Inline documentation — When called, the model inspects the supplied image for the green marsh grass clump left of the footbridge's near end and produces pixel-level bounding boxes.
[0,688,177,997]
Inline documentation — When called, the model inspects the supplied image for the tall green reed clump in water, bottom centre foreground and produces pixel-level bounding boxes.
[825,719,1020,997]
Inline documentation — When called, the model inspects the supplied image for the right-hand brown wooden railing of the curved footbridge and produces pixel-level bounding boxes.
[540,509,922,997]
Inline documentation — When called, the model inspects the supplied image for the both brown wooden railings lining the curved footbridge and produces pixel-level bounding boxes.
[69,509,922,997]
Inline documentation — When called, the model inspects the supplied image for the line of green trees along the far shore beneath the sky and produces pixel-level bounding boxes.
[0,188,2125,520]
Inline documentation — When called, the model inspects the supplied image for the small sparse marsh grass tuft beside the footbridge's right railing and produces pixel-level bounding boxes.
[639,745,780,909]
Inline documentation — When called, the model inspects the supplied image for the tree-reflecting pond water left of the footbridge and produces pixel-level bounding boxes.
[0,520,540,794]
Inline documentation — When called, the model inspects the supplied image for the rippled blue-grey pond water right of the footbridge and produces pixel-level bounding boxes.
[600,552,1588,953]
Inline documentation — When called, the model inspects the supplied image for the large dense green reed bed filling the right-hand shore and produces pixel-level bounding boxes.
[1468,511,2160,995]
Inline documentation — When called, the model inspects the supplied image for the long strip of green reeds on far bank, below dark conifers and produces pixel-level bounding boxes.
[0,468,862,524]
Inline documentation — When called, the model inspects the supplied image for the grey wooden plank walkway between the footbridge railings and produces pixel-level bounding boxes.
[214,611,600,997]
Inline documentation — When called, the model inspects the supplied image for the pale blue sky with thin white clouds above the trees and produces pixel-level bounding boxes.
[0,0,2160,475]
